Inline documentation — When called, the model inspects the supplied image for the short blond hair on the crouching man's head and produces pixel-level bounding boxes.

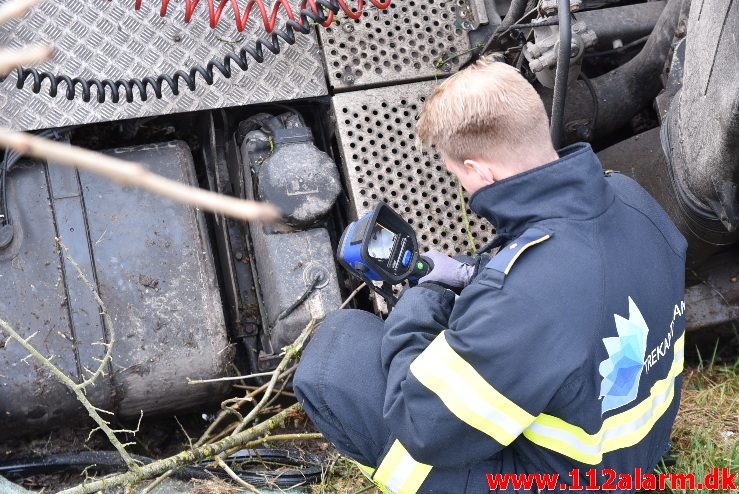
[418,59,551,162]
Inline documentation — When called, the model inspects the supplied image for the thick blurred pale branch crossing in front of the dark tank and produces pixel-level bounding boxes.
[0,129,280,222]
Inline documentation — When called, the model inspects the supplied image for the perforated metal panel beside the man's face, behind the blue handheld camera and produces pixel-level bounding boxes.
[333,81,493,254]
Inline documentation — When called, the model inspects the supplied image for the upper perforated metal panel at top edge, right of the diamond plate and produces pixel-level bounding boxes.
[320,0,476,89]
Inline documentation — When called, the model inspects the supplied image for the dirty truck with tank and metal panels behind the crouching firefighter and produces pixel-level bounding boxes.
[0,0,739,437]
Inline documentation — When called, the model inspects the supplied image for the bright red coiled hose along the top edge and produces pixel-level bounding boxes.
[136,0,392,33]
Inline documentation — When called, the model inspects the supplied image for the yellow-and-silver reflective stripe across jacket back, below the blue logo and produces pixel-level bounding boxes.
[523,335,685,465]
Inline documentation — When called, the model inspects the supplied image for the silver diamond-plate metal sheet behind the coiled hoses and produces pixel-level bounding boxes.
[0,0,327,130]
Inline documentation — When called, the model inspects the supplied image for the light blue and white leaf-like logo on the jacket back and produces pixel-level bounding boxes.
[598,297,649,414]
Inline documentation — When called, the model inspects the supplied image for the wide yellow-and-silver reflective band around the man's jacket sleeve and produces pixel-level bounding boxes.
[411,331,534,446]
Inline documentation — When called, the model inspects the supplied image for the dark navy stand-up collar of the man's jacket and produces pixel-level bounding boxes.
[470,143,614,237]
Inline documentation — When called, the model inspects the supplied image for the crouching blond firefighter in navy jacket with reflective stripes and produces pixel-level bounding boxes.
[294,61,687,494]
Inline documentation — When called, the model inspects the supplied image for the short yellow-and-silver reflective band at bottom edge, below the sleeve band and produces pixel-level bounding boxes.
[371,439,431,494]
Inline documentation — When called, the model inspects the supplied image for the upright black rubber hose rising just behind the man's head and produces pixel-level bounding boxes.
[549,0,572,149]
